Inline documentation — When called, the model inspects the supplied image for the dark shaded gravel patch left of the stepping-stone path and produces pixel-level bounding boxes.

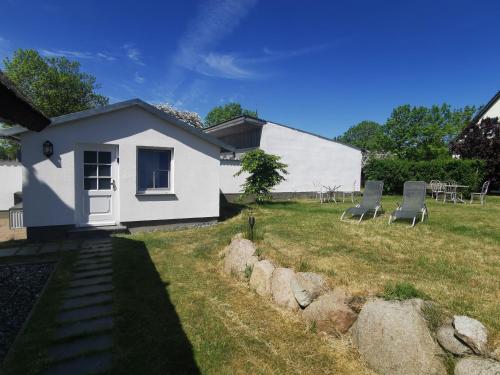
[0,262,55,362]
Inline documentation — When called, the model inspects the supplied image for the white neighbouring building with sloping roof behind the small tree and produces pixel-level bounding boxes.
[205,116,362,199]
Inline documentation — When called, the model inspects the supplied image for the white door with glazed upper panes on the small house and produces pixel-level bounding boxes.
[76,145,118,226]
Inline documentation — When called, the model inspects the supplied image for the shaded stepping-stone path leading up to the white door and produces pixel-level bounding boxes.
[39,238,113,375]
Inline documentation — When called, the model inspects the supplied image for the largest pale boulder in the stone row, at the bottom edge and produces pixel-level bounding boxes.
[351,299,446,375]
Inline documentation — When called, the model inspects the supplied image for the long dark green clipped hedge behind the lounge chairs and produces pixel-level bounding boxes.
[364,159,486,195]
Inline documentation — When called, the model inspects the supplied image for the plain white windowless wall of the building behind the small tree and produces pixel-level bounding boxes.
[221,122,361,194]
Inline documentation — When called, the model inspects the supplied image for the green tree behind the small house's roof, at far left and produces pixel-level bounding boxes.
[4,49,109,117]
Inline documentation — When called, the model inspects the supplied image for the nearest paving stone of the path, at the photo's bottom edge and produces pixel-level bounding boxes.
[42,352,112,375]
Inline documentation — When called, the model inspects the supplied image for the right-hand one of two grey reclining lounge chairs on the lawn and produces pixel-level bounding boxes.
[389,181,429,228]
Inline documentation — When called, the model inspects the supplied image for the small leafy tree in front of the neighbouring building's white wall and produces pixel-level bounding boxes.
[235,149,288,203]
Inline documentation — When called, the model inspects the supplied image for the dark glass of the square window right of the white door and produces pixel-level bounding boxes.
[137,149,170,191]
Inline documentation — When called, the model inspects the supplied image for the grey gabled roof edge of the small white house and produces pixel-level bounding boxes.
[0,99,234,151]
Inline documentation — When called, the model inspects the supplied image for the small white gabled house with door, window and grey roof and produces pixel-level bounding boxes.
[0,99,233,239]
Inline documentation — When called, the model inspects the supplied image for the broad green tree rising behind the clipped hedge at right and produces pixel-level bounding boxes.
[381,104,476,160]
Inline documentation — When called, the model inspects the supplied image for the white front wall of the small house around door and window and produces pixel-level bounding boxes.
[22,108,220,226]
